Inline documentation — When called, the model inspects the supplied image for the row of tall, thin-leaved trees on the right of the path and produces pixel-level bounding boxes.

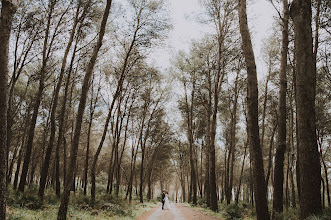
[172,0,331,219]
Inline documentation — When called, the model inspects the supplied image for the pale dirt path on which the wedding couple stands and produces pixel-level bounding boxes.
[137,203,220,220]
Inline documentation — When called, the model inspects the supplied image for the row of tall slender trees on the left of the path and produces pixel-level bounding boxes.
[0,0,173,219]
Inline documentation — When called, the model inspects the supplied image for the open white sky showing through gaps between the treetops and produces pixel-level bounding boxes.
[153,0,277,79]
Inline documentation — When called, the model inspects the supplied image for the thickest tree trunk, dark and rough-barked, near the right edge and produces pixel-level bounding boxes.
[291,0,322,219]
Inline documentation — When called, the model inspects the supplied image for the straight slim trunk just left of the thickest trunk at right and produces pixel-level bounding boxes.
[273,0,289,216]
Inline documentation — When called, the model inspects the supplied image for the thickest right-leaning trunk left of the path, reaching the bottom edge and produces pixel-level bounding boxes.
[57,0,112,220]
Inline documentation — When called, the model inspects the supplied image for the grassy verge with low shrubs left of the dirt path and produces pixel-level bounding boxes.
[7,188,158,220]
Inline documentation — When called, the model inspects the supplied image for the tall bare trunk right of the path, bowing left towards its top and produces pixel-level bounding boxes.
[238,0,270,220]
